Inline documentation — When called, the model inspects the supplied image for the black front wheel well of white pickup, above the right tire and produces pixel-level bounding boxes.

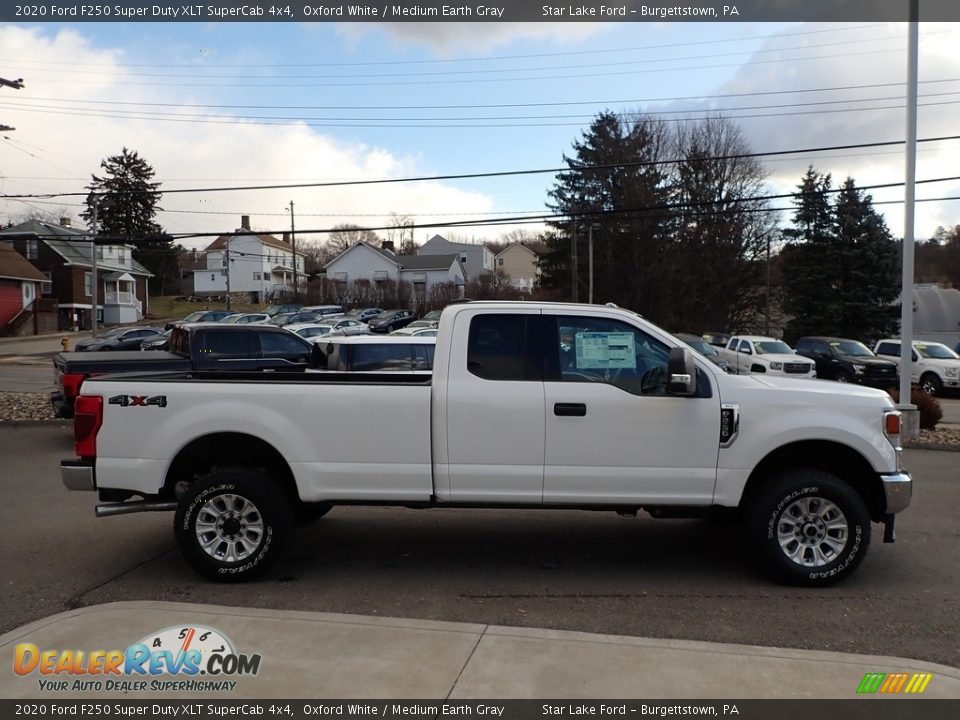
[741,440,885,522]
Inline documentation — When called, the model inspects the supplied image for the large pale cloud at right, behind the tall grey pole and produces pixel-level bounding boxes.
[696,23,960,238]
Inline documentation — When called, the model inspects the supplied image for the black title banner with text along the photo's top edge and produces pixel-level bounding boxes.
[0,0,960,22]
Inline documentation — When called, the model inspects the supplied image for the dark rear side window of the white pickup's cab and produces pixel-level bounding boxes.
[467,313,543,380]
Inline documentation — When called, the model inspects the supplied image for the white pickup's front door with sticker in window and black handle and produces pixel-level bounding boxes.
[543,310,720,505]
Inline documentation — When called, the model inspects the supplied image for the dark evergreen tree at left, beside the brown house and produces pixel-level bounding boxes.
[81,148,177,292]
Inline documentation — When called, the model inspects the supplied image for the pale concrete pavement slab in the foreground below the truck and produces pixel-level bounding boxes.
[0,601,960,700]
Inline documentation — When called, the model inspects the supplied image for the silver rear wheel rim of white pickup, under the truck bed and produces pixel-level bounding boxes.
[194,494,264,563]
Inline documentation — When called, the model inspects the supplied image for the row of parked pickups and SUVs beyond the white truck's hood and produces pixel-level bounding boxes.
[677,333,960,395]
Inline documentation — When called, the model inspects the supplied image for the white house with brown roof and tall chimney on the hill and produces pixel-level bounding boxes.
[193,215,307,302]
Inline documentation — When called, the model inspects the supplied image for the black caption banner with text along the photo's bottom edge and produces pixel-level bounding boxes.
[0,698,960,720]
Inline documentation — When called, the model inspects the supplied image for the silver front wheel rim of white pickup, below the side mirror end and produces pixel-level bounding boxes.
[777,497,850,567]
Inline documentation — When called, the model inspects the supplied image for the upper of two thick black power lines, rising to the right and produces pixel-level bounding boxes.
[0,135,960,199]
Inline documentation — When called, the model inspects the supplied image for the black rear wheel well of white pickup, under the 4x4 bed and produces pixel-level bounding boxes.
[163,433,300,500]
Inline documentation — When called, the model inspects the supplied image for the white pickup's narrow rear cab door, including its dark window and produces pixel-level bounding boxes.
[432,309,545,504]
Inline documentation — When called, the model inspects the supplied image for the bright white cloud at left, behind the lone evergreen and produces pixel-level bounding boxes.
[0,26,499,246]
